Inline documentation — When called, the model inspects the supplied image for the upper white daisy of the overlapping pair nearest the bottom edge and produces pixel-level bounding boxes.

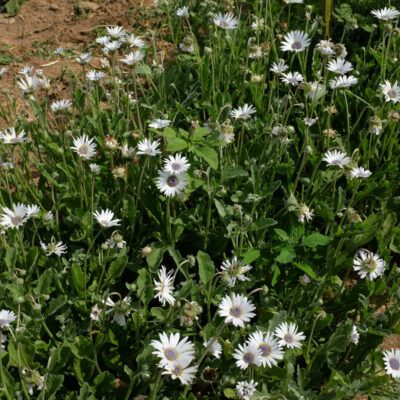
[150,332,195,368]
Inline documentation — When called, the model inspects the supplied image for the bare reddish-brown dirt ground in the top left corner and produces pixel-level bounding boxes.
[0,0,170,120]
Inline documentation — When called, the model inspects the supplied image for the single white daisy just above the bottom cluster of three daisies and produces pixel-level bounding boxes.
[218,293,256,328]
